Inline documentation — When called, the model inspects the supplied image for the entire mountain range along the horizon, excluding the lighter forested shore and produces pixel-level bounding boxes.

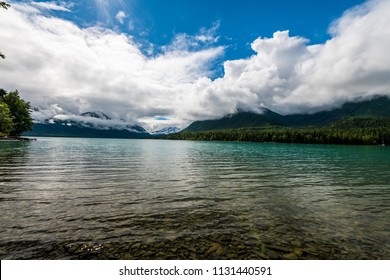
[24,96,390,138]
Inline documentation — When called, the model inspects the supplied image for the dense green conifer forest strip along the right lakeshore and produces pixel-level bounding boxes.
[164,117,390,145]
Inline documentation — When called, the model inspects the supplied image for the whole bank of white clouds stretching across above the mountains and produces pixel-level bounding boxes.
[0,0,390,129]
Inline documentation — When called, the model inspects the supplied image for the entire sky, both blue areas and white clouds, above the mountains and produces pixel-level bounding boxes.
[0,0,390,131]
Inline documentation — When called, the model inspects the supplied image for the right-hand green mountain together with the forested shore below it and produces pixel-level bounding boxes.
[179,96,390,145]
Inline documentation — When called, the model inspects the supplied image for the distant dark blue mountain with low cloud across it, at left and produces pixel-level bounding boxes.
[25,111,150,138]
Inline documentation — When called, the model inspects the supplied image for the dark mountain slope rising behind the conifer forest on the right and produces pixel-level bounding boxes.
[183,96,390,132]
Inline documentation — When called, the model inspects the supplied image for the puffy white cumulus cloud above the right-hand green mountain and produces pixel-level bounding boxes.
[188,0,390,118]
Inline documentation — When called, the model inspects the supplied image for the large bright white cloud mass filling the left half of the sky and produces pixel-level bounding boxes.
[0,4,224,129]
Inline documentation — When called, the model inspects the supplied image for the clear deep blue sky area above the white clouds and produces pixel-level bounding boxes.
[54,0,364,59]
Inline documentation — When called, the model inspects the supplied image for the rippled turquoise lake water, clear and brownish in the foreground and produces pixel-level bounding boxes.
[0,138,390,259]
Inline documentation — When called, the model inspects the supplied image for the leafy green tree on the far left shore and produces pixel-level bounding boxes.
[0,90,33,136]
